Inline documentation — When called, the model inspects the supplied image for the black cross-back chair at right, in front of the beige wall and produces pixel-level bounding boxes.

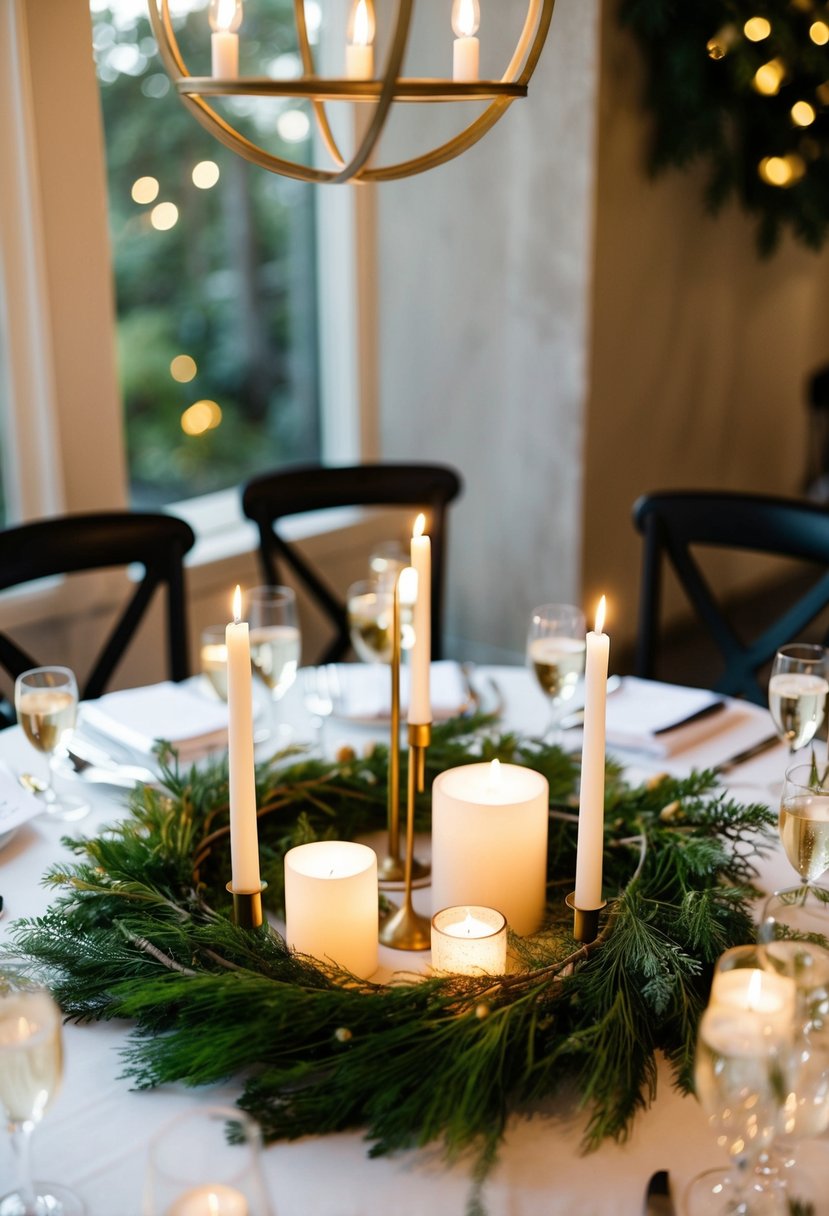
[633,491,829,704]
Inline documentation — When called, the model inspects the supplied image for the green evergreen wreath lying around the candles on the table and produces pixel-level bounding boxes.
[6,716,772,1210]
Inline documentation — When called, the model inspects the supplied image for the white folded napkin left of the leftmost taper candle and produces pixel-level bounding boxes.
[83,680,227,761]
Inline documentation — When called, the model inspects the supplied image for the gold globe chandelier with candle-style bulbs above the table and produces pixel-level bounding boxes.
[148,0,556,182]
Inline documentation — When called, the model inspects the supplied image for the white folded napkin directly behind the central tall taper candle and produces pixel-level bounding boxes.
[334,659,469,722]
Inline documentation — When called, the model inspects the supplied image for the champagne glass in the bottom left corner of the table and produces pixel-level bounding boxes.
[0,972,85,1216]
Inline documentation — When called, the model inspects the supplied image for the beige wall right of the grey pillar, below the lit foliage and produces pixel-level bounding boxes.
[583,0,829,643]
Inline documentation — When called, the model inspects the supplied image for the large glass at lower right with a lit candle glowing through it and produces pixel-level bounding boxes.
[683,998,790,1216]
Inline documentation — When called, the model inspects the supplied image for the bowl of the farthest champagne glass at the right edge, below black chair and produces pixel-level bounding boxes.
[768,643,829,753]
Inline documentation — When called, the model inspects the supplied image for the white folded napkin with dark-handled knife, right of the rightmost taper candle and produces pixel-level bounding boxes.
[607,676,726,756]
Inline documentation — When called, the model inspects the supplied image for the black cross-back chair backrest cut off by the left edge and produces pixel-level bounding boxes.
[0,511,196,698]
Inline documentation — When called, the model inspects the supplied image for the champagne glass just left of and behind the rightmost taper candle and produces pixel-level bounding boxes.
[526,604,585,743]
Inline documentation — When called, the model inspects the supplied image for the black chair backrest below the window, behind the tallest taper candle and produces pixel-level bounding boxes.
[242,463,462,663]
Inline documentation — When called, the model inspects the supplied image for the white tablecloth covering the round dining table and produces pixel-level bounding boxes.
[0,668,811,1216]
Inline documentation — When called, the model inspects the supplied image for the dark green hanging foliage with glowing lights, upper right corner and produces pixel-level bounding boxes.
[620,0,829,255]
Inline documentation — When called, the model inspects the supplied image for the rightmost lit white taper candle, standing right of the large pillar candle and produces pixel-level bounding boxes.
[575,596,610,912]
